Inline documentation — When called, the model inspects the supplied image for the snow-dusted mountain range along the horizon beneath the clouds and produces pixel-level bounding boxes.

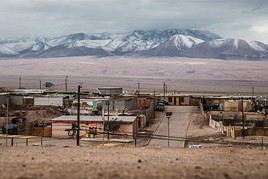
[0,29,268,60]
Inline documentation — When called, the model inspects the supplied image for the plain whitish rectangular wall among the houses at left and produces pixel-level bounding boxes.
[34,96,63,107]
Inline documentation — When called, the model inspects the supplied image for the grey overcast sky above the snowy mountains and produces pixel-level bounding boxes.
[0,0,268,43]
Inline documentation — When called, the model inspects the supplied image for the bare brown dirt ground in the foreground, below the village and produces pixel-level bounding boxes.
[0,140,268,179]
